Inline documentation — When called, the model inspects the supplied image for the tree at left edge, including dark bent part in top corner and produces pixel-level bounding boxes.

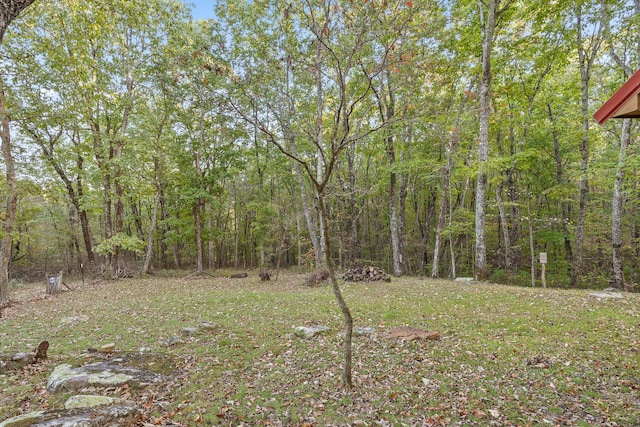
[0,0,34,303]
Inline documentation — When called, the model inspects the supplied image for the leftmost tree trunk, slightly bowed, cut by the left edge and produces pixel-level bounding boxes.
[0,75,17,303]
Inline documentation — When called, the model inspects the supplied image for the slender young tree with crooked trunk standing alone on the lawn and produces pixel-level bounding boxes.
[219,1,411,388]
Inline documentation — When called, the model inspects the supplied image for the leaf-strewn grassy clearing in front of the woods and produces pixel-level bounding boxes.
[0,272,640,427]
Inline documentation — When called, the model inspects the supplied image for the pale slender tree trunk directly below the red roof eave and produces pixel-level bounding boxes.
[611,119,631,289]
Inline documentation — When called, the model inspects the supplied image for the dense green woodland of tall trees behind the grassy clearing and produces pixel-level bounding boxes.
[0,0,640,300]
